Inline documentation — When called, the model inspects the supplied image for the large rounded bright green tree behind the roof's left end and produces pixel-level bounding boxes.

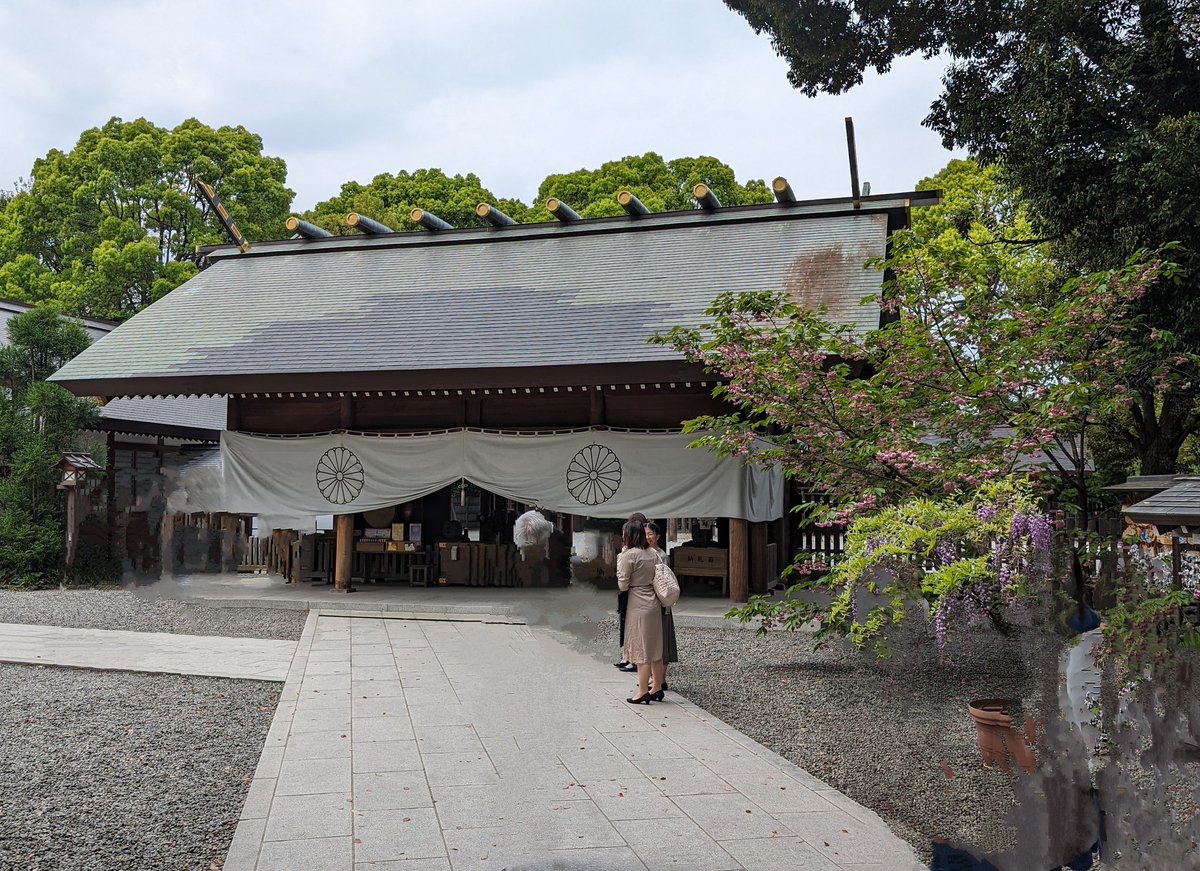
[0,118,293,319]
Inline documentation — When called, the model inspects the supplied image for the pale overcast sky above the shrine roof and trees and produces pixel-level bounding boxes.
[0,0,952,210]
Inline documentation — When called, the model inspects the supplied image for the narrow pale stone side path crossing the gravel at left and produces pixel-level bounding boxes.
[0,623,296,680]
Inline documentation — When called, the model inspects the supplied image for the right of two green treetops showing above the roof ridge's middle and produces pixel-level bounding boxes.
[529,151,772,221]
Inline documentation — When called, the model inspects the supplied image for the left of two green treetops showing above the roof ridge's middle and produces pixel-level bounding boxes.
[304,169,528,234]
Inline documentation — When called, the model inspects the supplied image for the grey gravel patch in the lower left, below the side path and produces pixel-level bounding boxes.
[0,665,281,871]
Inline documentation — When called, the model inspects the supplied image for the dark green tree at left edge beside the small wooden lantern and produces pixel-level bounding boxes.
[0,306,98,587]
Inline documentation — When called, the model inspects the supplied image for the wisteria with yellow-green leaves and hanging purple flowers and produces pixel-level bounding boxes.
[728,476,1056,655]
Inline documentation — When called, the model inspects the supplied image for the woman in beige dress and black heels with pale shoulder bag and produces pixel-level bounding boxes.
[617,521,666,704]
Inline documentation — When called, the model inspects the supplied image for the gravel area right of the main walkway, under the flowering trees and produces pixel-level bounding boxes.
[670,626,1070,859]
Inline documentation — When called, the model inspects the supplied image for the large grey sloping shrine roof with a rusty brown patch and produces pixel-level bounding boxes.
[54,192,938,396]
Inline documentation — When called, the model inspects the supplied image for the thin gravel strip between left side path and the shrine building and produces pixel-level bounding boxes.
[0,589,308,641]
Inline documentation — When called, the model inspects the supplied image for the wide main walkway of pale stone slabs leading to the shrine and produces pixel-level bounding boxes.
[224,612,919,871]
